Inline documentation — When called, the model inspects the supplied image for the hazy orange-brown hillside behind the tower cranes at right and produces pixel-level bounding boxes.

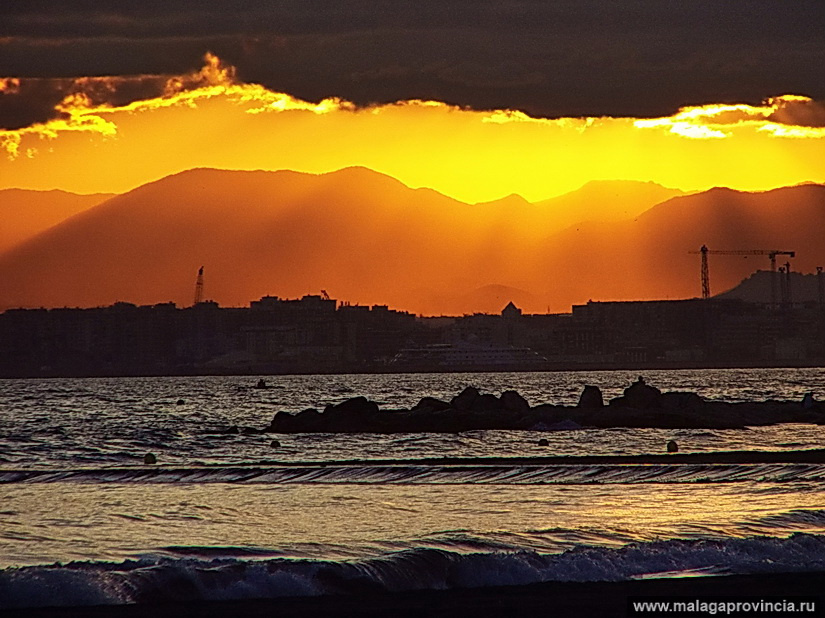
[531,185,825,302]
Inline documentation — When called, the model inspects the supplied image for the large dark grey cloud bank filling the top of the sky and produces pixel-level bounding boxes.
[0,0,825,125]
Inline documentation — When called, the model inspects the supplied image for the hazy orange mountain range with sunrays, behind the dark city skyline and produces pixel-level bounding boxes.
[0,168,825,315]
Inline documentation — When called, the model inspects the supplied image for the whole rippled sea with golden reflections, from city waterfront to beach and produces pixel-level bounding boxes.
[0,368,825,609]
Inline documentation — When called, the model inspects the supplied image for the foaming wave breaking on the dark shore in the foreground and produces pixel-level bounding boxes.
[0,533,825,609]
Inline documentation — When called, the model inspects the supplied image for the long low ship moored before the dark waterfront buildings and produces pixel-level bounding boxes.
[390,343,547,370]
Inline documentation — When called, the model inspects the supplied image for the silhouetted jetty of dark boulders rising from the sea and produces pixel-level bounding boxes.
[262,377,825,433]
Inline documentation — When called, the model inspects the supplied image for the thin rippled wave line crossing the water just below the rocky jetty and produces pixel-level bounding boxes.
[0,463,825,485]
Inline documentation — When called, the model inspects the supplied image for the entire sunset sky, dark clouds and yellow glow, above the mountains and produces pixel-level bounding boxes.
[0,0,825,202]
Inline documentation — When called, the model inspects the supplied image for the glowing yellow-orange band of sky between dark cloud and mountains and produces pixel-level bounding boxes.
[0,55,825,202]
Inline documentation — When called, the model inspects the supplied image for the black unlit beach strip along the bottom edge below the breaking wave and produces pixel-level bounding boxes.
[0,572,825,618]
